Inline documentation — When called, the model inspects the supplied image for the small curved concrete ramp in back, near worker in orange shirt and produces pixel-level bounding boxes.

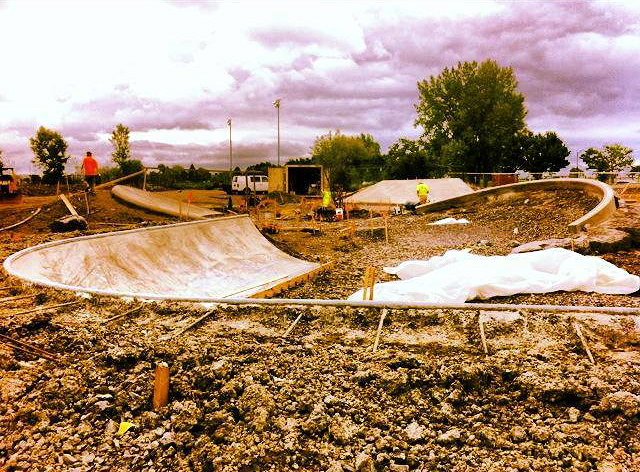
[111,185,222,220]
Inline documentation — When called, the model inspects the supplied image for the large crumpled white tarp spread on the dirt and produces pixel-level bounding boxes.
[349,248,640,303]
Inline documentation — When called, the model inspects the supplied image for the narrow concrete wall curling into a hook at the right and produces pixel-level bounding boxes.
[416,179,617,234]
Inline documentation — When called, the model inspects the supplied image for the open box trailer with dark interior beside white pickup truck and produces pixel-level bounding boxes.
[269,164,329,195]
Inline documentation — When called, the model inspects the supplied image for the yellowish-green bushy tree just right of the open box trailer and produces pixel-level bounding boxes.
[311,131,381,190]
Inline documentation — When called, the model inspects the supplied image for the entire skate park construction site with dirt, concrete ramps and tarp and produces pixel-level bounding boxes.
[0,179,640,472]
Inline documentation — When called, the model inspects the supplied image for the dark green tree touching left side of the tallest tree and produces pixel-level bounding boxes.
[385,138,447,179]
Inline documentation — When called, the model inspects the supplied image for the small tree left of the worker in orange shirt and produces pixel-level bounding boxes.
[29,126,69,184]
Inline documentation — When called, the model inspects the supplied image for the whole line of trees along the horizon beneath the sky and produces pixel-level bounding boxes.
[16,60,633,189]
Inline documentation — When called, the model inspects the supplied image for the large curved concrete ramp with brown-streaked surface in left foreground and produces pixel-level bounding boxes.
[4,215,324,301]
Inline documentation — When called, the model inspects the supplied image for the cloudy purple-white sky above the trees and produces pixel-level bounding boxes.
[0,0,640,172]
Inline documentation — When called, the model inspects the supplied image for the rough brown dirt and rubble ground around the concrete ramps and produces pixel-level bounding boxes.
[0,186,640,472]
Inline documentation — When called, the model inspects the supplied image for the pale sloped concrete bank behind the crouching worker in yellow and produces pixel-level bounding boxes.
[344,178,473,205]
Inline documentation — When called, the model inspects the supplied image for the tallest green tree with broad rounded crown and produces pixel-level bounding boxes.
[415,60,527,172]
